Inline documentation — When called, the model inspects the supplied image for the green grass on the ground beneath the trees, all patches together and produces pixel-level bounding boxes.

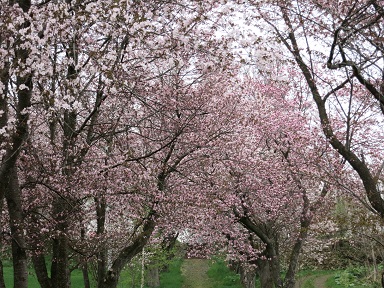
[3,259,381,288]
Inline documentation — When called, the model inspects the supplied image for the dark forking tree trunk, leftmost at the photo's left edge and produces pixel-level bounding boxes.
[0,0,33,288]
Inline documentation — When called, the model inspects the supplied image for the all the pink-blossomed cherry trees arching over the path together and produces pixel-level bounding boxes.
[0,0,384,288]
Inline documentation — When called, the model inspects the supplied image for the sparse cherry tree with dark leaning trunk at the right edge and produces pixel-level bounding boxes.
[243,1,384,222]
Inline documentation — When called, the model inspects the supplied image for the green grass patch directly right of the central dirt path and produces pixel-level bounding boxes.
[207,259,242,288]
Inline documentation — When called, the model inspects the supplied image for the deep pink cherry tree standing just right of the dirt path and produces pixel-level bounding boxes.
[166,75,341,287]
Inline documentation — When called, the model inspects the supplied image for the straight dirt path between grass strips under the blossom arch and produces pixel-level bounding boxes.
[181,259,211,288]
